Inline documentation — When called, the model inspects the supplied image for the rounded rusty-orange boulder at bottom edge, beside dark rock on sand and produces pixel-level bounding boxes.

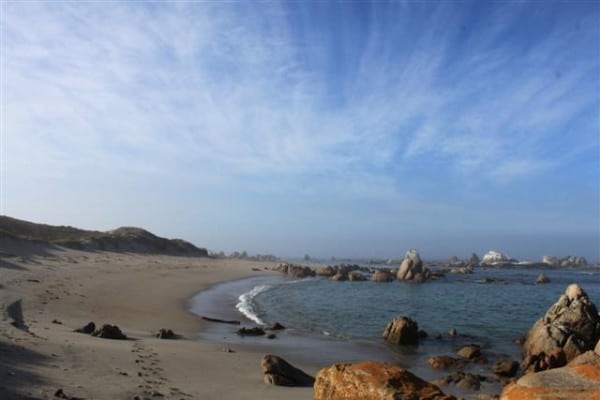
[314,361,454,400]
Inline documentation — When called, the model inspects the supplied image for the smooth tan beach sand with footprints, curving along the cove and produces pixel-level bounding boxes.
[0,238,318,400]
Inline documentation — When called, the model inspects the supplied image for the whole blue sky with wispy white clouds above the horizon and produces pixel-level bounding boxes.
[0,0,600,261]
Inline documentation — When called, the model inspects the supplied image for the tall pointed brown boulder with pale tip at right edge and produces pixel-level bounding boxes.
[521,284,600,371]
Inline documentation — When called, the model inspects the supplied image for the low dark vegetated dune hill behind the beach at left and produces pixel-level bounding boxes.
[0,216,208,257]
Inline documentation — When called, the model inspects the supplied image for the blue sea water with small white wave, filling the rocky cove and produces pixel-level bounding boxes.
[190,267,600,397]
